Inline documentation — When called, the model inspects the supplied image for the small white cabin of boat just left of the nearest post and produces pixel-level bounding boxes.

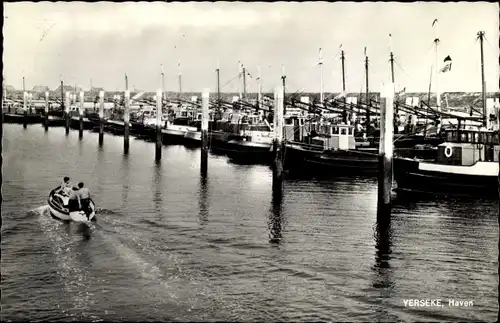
[312,124,356,150]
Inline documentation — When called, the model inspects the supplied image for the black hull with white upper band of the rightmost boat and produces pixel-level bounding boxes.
[393,157,498,198]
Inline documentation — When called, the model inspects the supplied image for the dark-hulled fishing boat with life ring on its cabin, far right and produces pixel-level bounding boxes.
[394,128,500,197]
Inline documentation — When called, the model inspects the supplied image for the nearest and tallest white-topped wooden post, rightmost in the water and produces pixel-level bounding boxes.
[378,83,394,214]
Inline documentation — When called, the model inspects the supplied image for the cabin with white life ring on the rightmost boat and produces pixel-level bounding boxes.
[436,129,500,166]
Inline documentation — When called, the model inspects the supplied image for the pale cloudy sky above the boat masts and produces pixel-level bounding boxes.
[3,2,499,92]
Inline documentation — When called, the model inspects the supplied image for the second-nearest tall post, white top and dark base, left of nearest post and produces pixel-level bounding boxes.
[273,86,284,192]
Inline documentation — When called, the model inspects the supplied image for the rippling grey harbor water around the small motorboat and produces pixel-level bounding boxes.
[1,124,499,321]
